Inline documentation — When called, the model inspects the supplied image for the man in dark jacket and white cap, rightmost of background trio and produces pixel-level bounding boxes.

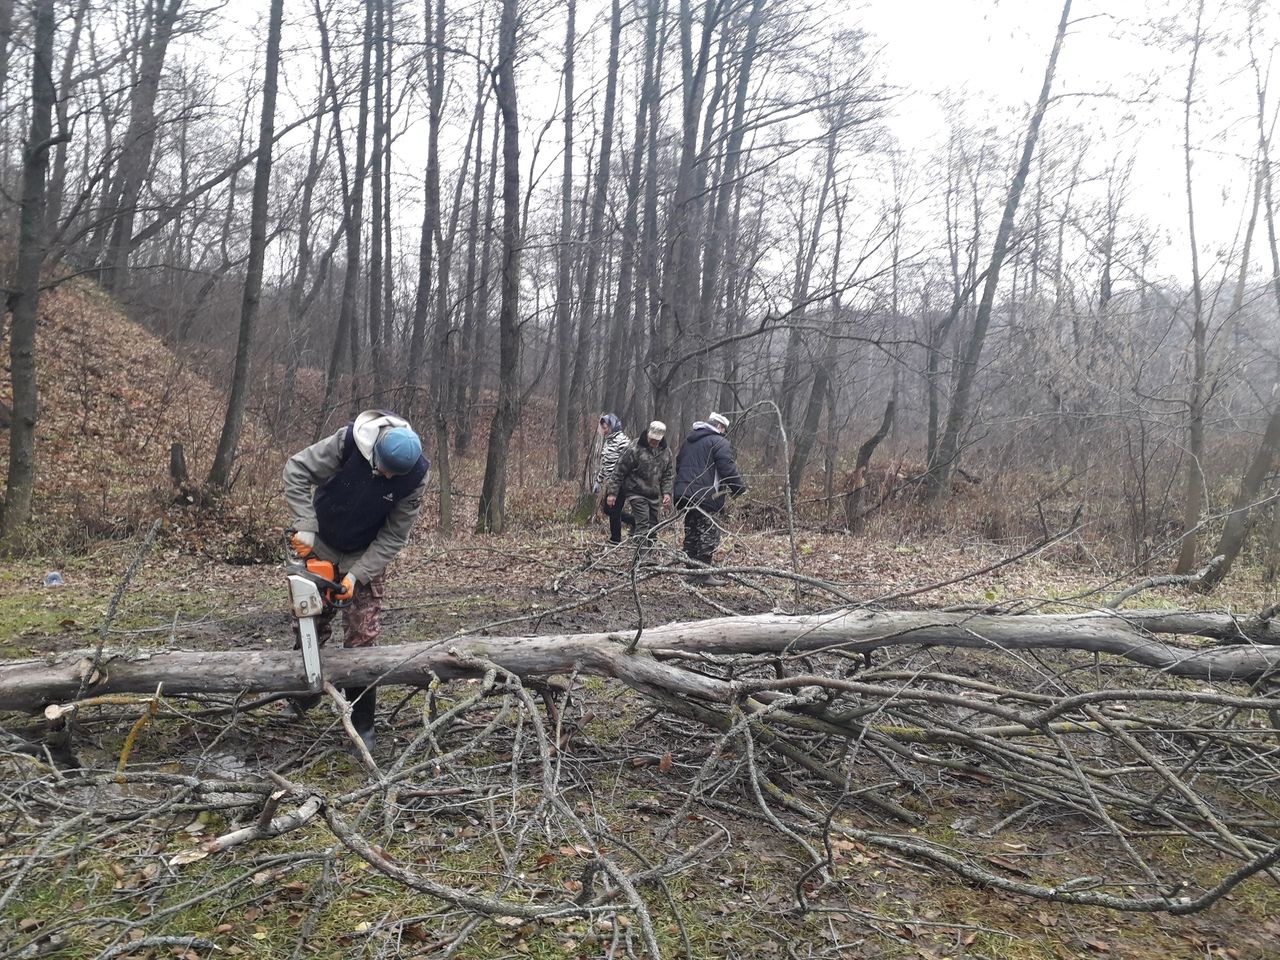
[675,412,746,586]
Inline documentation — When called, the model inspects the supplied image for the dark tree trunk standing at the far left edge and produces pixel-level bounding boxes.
[0,0,55,552]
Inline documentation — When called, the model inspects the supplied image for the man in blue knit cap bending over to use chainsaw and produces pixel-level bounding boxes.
[284,410,430,750]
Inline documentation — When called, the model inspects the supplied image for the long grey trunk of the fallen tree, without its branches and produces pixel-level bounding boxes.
[0,609,1280,710]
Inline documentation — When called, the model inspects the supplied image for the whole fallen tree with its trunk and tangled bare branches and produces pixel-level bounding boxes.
[0,567,1280,960]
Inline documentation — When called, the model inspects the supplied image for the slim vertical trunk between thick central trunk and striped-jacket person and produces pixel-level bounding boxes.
[556,0,578,480]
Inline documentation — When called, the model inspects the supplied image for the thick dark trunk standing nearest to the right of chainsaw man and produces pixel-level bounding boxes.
[476,0,521,534]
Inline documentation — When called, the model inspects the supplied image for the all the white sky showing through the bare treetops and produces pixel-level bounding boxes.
[204,0,1280,293]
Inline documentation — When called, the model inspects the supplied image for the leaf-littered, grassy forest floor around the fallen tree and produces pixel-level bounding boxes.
[0,526,1280,960]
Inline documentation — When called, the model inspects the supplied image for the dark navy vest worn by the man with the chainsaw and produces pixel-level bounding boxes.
[312,424,430,553]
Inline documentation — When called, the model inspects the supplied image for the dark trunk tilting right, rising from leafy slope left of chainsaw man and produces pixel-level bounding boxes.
[207,0,284,490]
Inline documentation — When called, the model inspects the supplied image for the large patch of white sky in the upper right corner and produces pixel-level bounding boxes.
[851,0,1277,282]
